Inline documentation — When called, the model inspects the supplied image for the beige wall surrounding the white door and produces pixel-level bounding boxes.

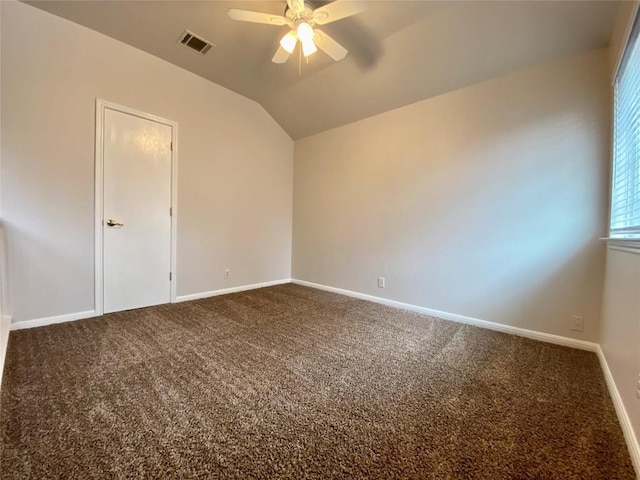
[0,2,293,321]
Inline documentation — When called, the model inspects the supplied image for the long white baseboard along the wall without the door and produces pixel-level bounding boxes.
[291,278,599,352]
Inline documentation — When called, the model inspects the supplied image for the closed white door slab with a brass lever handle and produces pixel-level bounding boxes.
[102,108,172,313]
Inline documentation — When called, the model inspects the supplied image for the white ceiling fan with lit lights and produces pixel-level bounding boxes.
[229,0,365,63]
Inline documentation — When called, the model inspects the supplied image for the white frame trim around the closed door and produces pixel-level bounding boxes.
[94,98,178,316]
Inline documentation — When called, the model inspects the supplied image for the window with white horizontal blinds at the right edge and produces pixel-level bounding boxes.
[610,17,640,239]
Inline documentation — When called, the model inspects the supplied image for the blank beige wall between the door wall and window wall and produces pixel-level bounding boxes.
[292,50,609,341]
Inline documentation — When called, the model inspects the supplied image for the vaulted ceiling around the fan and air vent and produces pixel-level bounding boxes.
[28,0,618,139]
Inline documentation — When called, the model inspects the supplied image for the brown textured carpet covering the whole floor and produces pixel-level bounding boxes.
[0,285,635,480]
